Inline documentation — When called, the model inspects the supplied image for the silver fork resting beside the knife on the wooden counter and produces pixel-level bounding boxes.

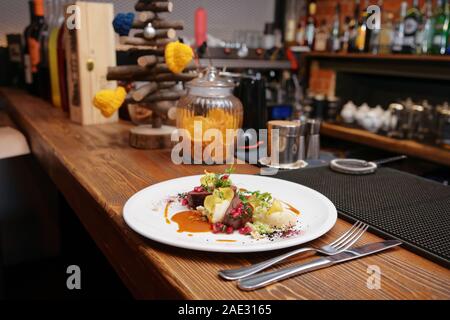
[219,221,369,280]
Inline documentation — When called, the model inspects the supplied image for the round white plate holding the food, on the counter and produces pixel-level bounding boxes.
[123,174,337,252]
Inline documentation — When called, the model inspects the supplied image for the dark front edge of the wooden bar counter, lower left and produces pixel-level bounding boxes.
[0,88,200,299]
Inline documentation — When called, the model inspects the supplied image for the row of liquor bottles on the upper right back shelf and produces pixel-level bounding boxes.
[294,0,450,61]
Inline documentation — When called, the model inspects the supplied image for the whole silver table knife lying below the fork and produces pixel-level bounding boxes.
[238,240,402,291]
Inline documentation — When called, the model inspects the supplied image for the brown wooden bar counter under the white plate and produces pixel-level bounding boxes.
[0,89,450,300]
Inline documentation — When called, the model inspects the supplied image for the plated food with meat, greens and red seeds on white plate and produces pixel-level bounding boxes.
[178,170,299,239]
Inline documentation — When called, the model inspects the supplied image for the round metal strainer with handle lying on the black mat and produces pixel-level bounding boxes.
[330,155,407,175]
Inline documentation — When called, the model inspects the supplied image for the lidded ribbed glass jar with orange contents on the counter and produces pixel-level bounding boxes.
[177,67,244,164]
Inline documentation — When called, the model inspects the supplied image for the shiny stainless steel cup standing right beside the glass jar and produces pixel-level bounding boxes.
[267,121,302,165]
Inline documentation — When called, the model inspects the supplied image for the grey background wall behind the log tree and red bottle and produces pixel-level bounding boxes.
[0,0,275,46]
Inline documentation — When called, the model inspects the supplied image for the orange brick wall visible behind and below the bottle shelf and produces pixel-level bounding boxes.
[309,0,425,94]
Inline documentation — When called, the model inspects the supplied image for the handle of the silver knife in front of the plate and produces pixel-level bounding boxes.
[238,258,333,291]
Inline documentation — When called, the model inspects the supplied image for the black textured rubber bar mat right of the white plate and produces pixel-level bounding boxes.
[275,167,450,268]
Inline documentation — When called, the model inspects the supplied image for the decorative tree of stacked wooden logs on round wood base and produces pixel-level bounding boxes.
[107,0,197,149]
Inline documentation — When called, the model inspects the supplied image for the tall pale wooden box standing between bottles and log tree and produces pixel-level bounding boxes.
[65,1,119,125]
